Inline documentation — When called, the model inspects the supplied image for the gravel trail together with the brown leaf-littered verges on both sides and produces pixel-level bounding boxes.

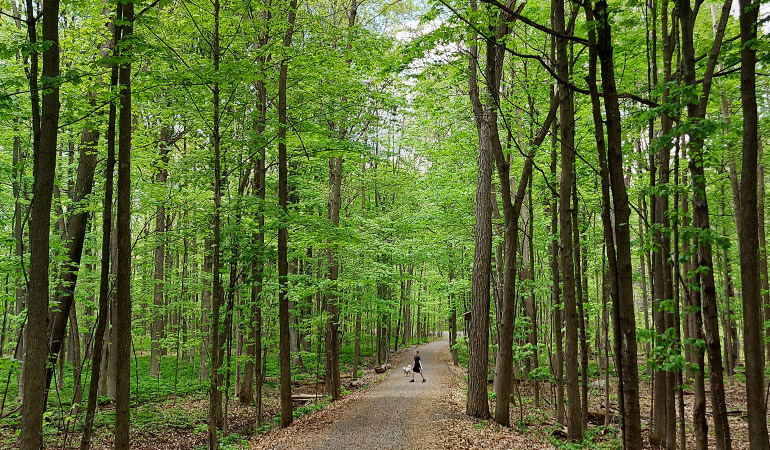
[251,339,554,450]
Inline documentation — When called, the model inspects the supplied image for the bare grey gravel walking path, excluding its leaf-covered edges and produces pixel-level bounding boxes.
[303,339,451,450]
